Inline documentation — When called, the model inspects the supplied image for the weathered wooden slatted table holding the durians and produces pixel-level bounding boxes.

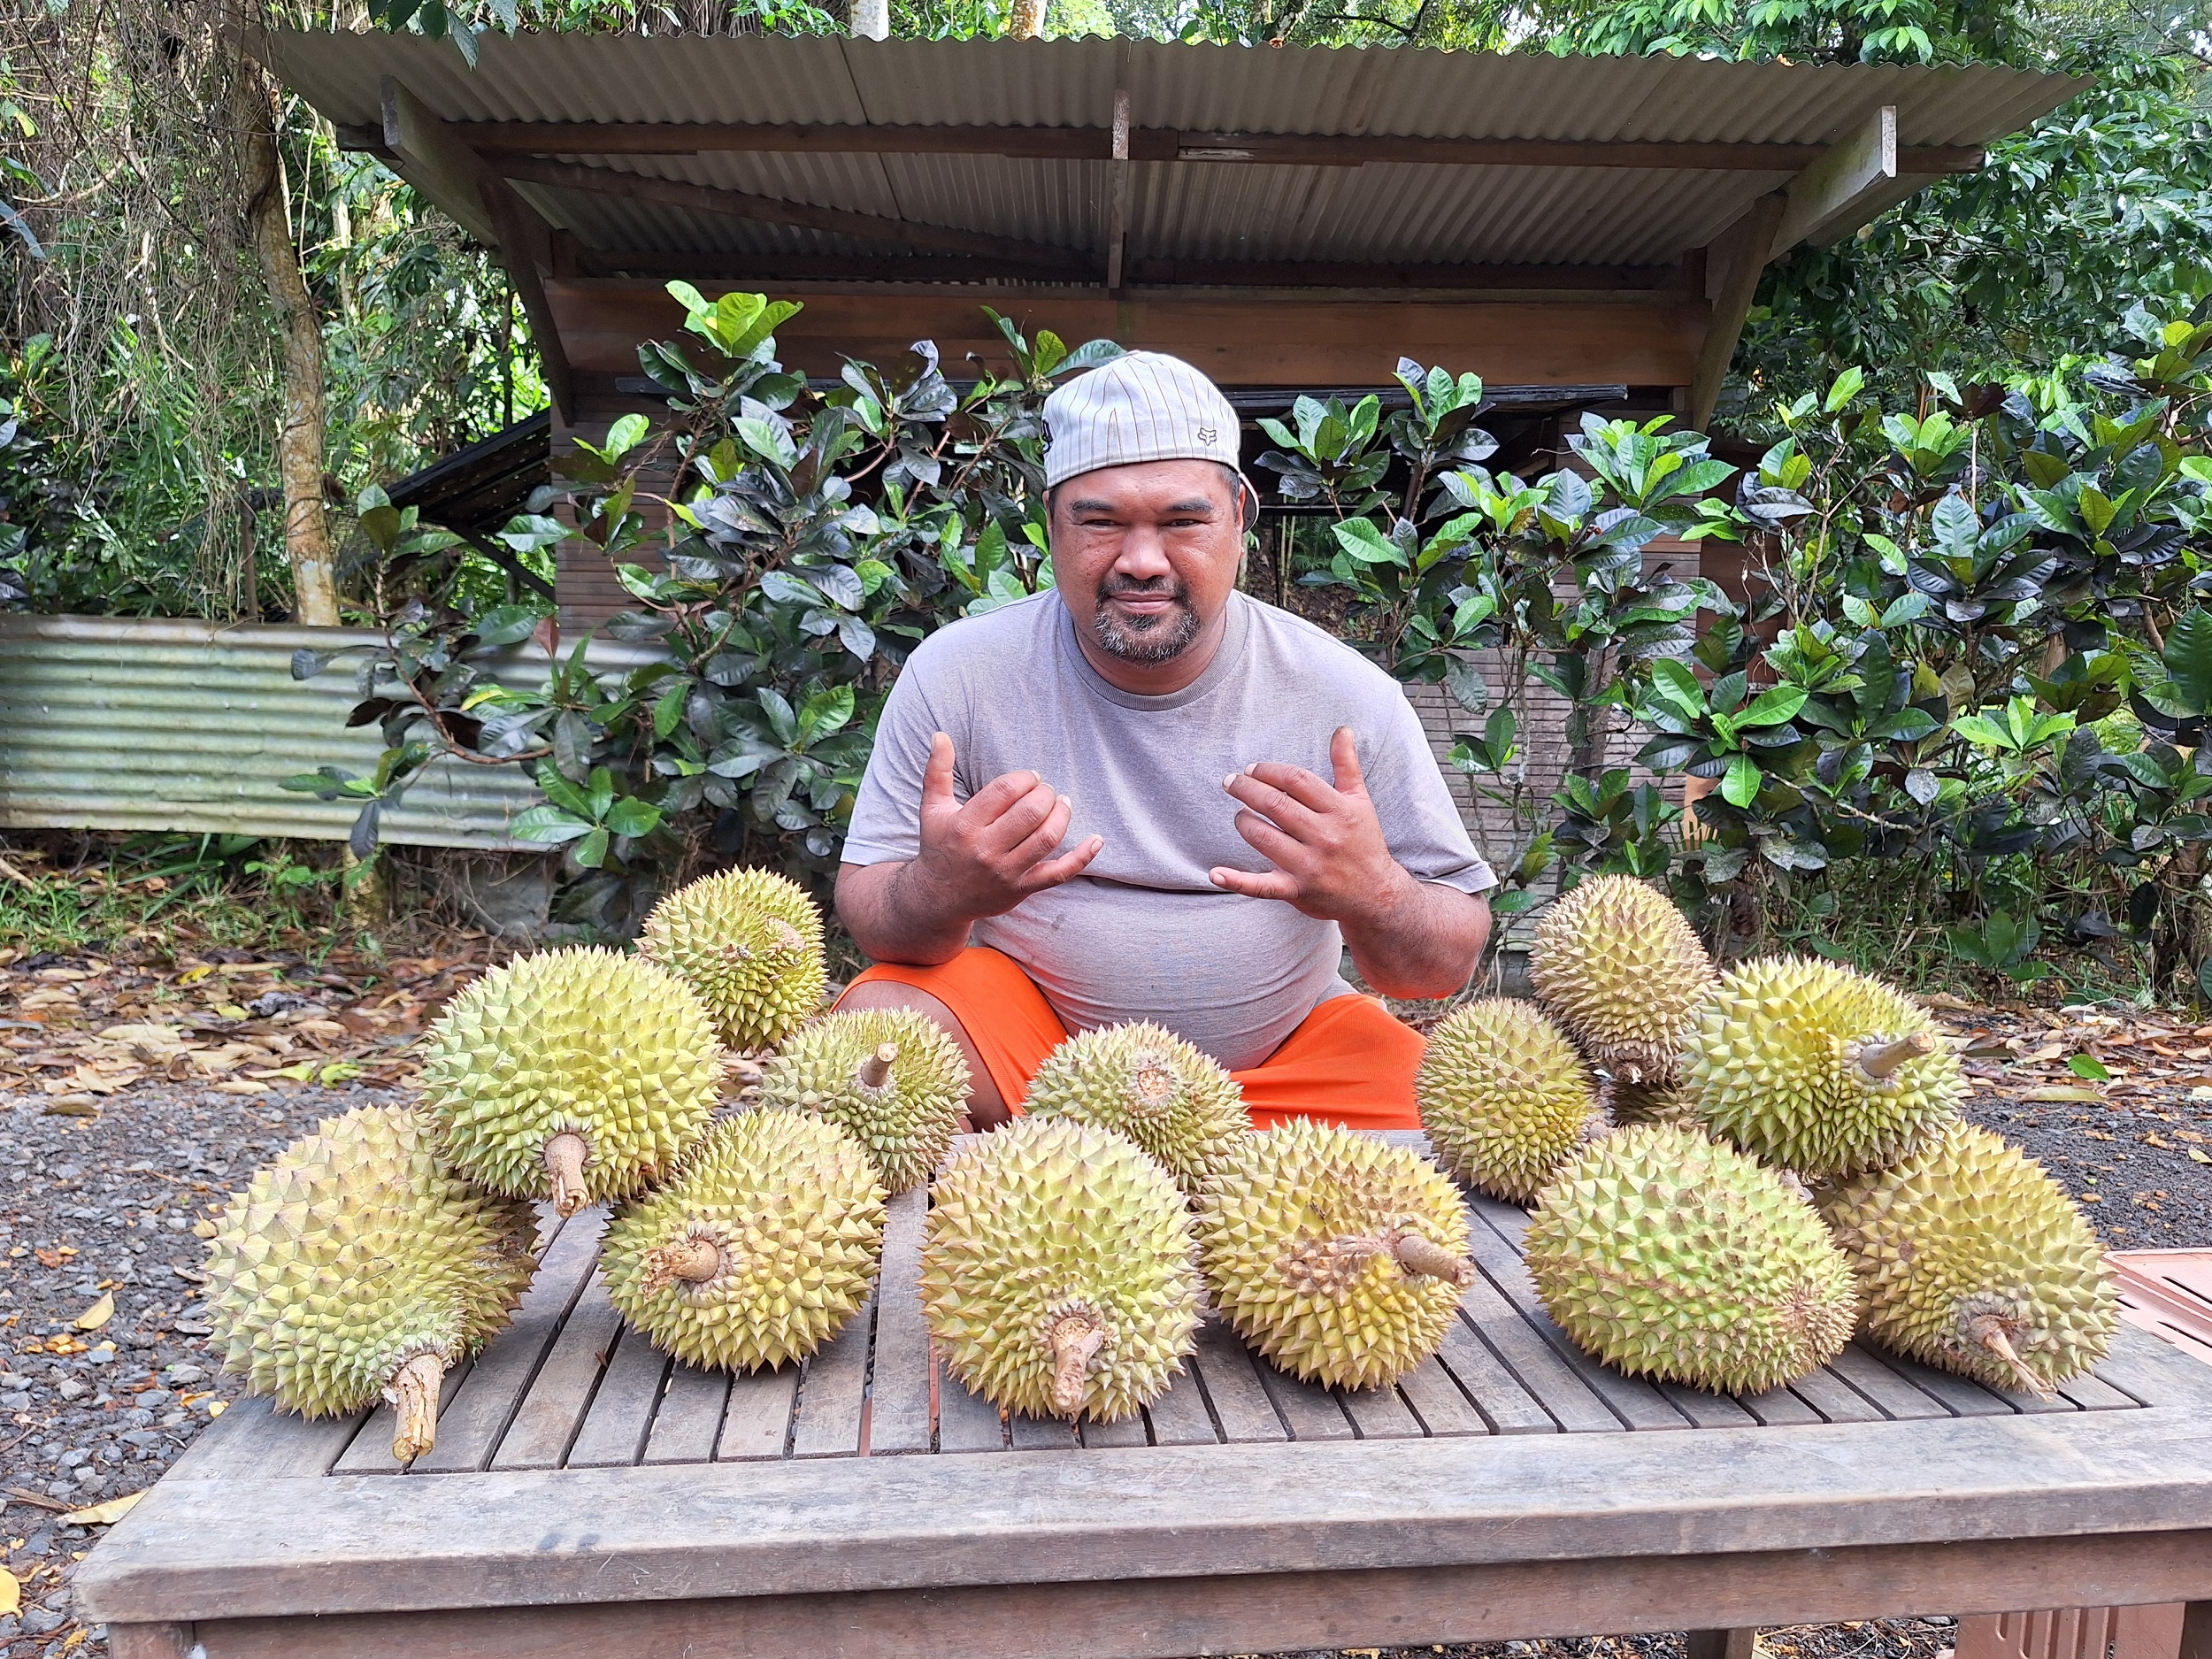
[78,1141,2212,1659]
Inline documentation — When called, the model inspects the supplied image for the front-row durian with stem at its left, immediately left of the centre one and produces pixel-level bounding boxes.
[600,1113,885,1371]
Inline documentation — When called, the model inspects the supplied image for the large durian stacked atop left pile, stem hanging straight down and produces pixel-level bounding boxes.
[423,949,721,1215]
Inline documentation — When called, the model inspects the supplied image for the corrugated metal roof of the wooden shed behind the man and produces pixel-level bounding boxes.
[261,34,2086,276]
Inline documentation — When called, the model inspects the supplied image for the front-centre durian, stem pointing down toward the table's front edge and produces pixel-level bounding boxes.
[923,1118,1199,1423]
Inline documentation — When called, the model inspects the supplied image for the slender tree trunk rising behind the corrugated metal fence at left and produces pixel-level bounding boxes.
[230,56,339,628]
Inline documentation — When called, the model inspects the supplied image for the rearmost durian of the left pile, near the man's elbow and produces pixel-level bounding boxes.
[637,870,827,1051]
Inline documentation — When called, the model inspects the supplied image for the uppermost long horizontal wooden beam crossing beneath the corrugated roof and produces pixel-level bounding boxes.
[339,122,1982,175]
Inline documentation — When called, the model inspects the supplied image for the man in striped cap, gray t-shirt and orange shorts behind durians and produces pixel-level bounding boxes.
[836,352,1494,1128]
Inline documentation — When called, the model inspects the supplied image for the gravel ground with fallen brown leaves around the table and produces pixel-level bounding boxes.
[0,938,2212,1659]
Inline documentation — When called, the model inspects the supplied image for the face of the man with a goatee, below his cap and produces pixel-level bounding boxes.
[1053,460,1243,666]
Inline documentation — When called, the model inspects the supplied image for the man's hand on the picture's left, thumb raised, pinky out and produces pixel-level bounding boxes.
[898,733,1106,929]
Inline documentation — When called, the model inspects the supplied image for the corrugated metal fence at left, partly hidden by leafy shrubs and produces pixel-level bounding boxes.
[0,618,641,849]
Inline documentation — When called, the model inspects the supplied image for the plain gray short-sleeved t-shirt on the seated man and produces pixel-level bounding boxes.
[845,591,1495,1069]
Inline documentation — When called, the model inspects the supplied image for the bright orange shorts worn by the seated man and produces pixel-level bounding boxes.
[836,945,1427,1128]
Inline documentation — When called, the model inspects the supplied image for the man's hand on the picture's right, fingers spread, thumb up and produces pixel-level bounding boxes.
[1208,726,1414,923]
